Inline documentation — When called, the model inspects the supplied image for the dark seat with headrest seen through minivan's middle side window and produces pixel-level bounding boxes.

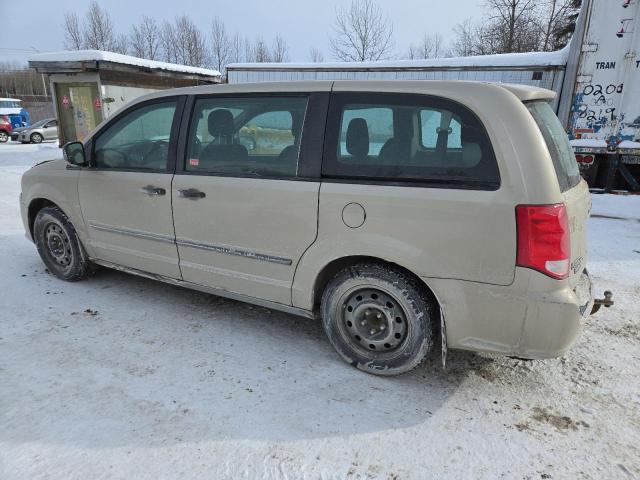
[198,108,249,170]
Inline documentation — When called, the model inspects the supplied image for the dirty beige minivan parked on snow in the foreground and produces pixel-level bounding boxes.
[21,81,593,375]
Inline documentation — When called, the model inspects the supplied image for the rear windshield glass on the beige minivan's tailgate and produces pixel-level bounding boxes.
[527,102,580,192]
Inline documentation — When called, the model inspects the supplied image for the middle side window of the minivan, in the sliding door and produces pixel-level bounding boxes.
[185,96,307,178]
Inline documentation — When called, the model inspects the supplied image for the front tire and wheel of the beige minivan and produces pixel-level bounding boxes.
[33,207,94,282]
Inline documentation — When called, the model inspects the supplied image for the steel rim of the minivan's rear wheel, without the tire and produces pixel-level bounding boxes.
[339,287,409,355]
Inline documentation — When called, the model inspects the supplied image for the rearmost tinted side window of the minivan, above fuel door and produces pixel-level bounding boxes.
[322,93,500,190]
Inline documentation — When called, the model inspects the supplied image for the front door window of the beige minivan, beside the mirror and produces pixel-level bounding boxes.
[94,100,177,171]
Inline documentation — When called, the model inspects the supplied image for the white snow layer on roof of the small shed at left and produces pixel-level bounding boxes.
[29,50,220,77]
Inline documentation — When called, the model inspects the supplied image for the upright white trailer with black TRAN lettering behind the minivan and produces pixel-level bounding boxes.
[560,0,640,191]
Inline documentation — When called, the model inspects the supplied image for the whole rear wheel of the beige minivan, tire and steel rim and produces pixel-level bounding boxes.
[321,263,435,376]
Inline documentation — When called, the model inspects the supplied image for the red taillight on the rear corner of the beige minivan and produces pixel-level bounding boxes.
[516,203,571,279]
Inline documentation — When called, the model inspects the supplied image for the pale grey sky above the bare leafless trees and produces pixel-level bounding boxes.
[0,0,482,61]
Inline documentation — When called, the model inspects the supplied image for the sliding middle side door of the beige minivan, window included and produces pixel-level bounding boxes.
[172,95,320,305]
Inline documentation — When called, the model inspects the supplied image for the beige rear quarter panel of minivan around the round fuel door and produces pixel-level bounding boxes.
[292,82,562,309]
